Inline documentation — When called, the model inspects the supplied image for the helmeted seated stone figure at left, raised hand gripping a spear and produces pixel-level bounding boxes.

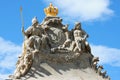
[22,17,42,52]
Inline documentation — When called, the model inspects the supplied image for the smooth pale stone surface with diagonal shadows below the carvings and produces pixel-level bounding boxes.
[22,63,109,80]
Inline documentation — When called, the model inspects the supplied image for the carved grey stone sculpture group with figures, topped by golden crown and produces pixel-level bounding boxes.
[9,4,109,79]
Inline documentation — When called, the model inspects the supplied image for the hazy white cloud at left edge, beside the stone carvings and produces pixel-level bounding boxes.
[0,37,21,78]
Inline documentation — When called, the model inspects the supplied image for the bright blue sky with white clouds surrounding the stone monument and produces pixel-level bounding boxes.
[0,0,120,80]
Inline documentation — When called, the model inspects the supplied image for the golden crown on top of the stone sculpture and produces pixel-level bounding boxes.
[44,3,58,17]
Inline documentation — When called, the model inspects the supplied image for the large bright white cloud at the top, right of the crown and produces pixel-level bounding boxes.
[46,0,113,21]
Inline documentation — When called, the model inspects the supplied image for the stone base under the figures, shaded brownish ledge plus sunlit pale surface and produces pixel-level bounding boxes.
[18,53,108,80]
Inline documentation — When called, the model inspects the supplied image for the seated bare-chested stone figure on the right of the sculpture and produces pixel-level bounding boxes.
[73,22,90,52]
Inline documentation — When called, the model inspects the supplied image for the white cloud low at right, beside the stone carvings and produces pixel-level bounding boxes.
[91,45,120,67]
